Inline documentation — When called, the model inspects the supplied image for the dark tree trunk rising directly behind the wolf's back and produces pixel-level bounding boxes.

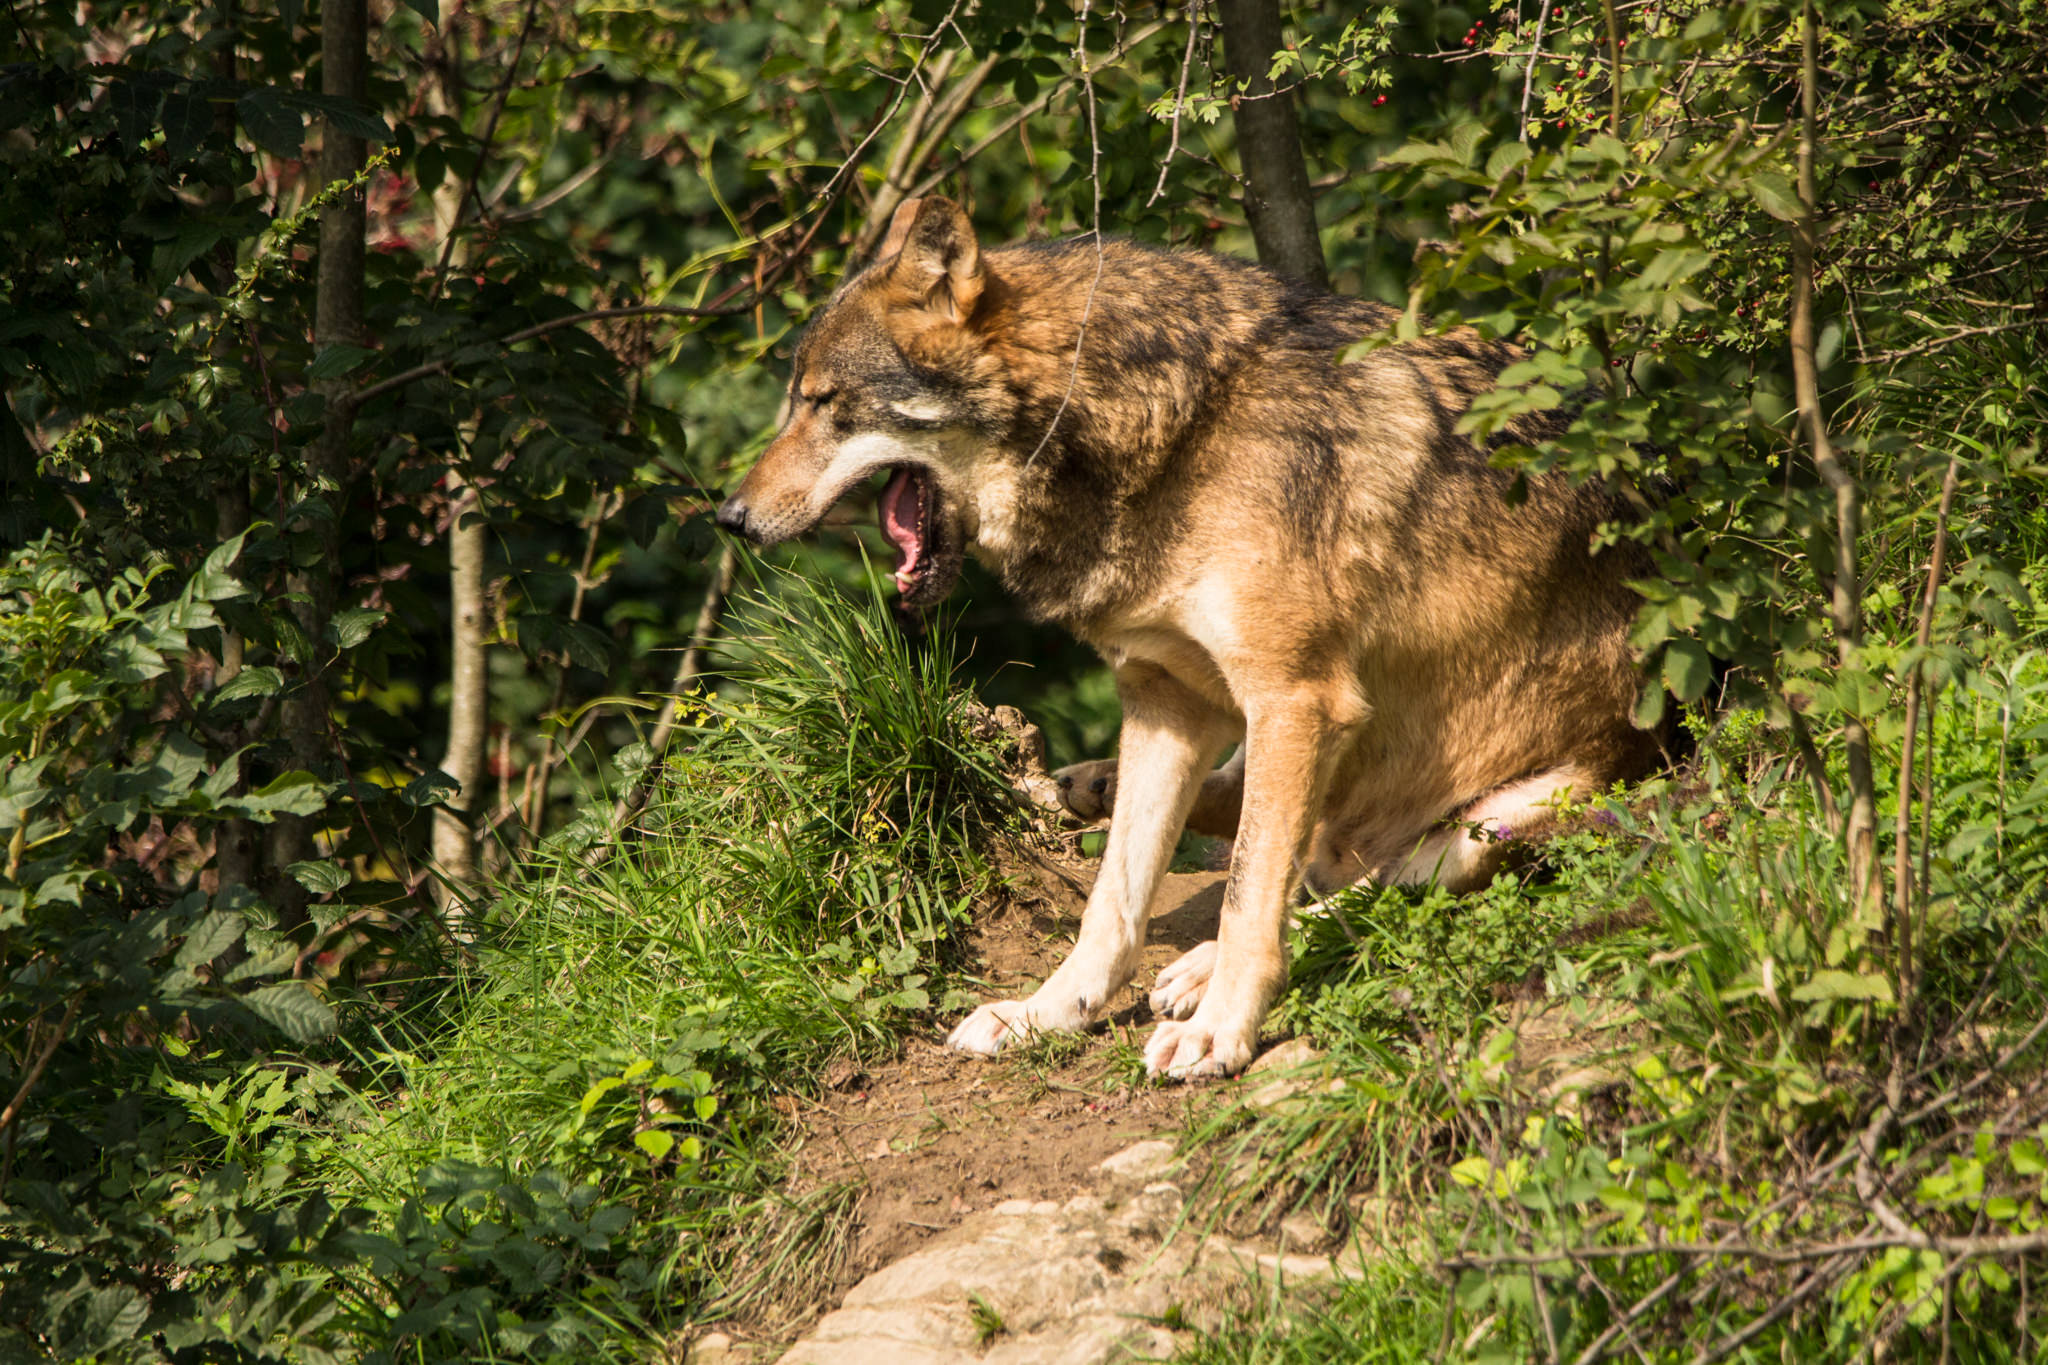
[1217,0,1329,289]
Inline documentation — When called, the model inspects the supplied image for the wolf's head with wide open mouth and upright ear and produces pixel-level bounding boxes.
[717,199,1004,610]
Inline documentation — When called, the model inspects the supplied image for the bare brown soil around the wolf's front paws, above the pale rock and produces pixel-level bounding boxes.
[795,862,1225,1308]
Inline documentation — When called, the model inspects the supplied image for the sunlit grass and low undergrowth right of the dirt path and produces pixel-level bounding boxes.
[1190,630,2048,1361]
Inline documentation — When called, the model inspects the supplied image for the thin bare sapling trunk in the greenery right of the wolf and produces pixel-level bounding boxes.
[1790,0,1878,905]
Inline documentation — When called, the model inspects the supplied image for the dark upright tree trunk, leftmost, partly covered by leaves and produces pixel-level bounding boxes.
[270,0,369,925]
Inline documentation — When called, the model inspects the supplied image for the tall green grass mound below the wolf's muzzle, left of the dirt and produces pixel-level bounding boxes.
[249,581,1012,1359]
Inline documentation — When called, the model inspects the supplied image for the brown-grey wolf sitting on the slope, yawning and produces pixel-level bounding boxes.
[717,196,1659,1076]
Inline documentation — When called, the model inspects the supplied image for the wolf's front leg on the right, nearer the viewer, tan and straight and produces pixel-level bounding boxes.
[1145,688,1364,1076]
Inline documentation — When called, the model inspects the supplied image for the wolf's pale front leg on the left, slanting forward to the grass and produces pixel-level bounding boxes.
[946,663,1235,1056]
